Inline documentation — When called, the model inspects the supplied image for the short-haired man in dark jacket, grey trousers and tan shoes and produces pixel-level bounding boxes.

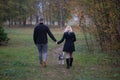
[33,19,56,67]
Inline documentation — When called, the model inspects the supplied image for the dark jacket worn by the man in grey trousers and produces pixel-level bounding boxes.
[33,23,56,44]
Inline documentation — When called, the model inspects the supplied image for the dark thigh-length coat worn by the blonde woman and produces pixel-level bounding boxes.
[58,32,76,52]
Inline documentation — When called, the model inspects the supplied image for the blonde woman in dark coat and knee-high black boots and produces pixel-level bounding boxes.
[57,26,76,69]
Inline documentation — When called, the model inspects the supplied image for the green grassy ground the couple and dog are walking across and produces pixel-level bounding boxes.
[0,28,120,80]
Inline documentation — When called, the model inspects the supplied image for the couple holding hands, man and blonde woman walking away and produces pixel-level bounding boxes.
[33,18,76,69]
